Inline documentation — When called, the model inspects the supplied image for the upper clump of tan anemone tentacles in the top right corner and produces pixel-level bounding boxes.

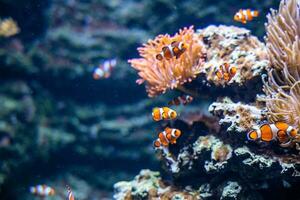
[265,0,300,72]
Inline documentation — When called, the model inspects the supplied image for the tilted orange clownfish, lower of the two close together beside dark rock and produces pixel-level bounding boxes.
[153,127,181,148]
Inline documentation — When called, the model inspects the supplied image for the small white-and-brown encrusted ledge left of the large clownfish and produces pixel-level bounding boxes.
[208,98,265,132]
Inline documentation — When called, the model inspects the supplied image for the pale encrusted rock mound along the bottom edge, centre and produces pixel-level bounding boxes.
[114,170,201,200]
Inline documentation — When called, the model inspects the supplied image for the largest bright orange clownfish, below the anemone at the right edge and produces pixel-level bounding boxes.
[247,122,298,145]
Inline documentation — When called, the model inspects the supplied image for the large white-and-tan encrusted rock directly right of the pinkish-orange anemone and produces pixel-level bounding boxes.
[197,25,269,86]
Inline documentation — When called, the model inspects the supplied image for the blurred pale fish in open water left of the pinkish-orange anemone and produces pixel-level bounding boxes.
[93,59,117,80]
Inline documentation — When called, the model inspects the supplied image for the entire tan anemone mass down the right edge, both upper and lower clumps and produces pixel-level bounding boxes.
[264,0,300,129]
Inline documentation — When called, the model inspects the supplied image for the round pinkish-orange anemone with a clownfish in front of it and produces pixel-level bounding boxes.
[128,26,204,97]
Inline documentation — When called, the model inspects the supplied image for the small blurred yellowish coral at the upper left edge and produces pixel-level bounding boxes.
[0,18,20,37]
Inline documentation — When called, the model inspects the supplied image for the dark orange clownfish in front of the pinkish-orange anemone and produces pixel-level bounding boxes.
[156,41,187,61]
